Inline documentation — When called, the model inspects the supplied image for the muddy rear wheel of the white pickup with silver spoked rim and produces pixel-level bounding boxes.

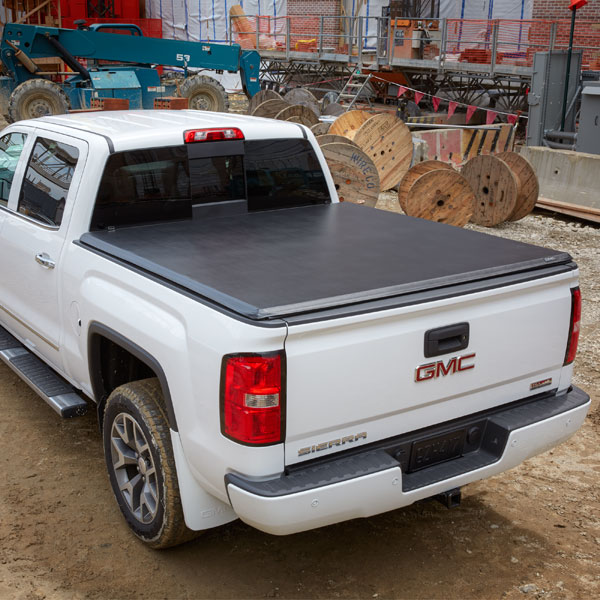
[103,378,197,549]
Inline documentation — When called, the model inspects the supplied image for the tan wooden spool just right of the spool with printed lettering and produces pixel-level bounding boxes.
[354,113,413,191]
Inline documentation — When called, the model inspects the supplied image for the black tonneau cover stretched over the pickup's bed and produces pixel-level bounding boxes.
[81,203,571,320]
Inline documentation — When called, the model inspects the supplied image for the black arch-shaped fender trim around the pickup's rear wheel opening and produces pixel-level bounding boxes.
[88,321,179,431]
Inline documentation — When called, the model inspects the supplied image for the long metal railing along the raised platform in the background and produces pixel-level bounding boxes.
[228,15,600,75]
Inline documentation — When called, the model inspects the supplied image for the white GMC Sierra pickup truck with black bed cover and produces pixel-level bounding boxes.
[0,111,590,548]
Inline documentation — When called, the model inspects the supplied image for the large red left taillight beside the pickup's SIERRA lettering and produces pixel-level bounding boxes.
[221,352,285,445]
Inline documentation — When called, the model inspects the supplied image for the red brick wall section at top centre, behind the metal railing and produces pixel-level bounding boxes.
[287,0,340,50]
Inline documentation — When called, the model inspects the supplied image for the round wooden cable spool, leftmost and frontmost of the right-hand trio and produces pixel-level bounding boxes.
[405,168,475,227]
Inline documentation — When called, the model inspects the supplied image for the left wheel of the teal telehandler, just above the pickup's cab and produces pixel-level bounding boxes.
[8,79,69,123]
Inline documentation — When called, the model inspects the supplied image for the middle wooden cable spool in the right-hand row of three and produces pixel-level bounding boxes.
[461,154,519,227]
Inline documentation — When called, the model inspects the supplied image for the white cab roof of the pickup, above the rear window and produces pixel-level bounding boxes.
[21,110,306,151]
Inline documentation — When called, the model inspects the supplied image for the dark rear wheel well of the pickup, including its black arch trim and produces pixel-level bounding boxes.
[88,324,177,431]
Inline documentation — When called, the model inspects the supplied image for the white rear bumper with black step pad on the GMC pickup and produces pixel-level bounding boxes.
[226,387,590,535]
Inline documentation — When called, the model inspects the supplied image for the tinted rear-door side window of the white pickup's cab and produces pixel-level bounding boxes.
[17,138,79,227]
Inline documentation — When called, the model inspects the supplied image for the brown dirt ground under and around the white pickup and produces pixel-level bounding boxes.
[0,115,600,600]
